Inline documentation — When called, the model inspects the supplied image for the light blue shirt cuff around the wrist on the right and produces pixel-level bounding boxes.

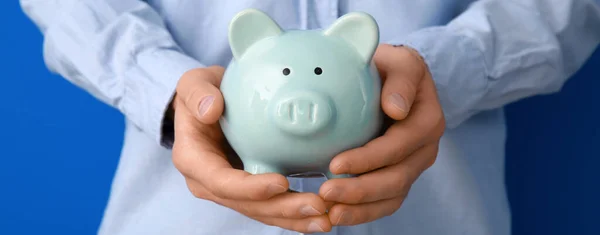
[388,26,489,129]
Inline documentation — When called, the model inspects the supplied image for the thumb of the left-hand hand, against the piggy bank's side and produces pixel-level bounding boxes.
[176,66,224,124]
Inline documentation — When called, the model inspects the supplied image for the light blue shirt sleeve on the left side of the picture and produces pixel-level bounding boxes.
[20,0,203,147]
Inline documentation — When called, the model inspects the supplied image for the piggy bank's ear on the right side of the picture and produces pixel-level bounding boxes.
[323,12,379,64]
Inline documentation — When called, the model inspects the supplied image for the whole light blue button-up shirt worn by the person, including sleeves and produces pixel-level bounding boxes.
[21,0,600,235]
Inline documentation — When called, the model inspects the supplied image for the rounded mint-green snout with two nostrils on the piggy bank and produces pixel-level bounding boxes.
[271,91,335,136]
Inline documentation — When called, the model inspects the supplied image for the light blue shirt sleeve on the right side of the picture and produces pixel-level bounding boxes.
[394,0,600,128]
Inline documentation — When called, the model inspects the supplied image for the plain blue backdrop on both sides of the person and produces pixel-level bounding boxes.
[0,0,600,235]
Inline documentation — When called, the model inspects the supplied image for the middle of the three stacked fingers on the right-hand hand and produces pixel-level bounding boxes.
[319,144,438,204]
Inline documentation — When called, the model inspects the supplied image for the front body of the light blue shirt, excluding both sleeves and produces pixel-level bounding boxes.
[99,0,510,235]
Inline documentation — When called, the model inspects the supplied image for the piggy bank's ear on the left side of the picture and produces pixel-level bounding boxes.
[229,9,282,58]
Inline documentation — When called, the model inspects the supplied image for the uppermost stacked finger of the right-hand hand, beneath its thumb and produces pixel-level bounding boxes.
[329,75,444,174]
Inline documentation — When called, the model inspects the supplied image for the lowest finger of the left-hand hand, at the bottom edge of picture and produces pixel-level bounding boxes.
[254,215,331,233]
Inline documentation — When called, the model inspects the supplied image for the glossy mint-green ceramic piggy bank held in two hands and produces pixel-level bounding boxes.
[219,9,383,179]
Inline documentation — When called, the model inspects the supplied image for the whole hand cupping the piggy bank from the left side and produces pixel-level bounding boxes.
[173,66,331,233]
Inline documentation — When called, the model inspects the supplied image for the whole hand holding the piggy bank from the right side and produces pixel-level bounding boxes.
[319,45,445,225]
